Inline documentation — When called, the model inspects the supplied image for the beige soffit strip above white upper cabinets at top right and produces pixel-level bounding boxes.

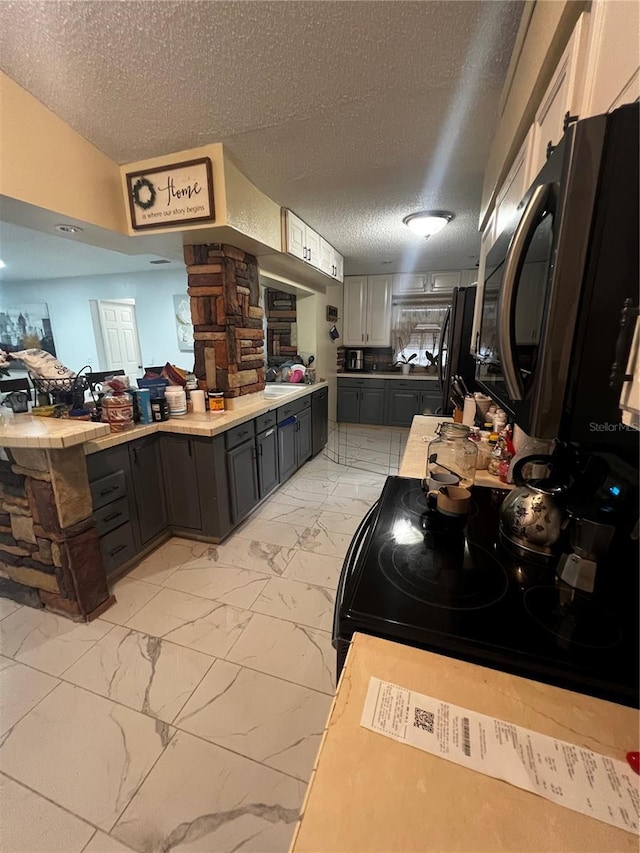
[480,0,588,230]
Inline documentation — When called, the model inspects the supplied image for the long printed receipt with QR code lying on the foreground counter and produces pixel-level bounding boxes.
[360,677,640,833]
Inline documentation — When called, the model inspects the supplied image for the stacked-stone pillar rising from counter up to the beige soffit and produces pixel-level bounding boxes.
[184,243,265,397]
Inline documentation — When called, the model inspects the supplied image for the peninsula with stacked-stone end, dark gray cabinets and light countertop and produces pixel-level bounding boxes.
[0,382,328,621]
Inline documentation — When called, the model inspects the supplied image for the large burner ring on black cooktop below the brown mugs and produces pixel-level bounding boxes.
[378,532,508,610]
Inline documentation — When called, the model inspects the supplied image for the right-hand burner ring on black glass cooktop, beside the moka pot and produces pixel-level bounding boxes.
[524,586,622,649]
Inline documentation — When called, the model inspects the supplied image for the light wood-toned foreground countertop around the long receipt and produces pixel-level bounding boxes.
[291,634,639,853]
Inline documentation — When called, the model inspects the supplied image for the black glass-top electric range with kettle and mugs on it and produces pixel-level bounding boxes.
[333,477,639,707]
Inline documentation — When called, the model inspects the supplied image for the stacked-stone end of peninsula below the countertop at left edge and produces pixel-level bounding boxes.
[0,445,113,621]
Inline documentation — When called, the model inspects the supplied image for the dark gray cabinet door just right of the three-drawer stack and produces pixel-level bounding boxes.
[129,435,168,545]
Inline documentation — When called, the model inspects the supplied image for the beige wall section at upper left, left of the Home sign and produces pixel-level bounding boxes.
[0,72,127,233]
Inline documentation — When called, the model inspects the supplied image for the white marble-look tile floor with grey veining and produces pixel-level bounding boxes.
[0,450,391,853]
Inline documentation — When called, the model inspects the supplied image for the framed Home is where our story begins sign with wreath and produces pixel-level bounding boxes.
[126,157,215,231]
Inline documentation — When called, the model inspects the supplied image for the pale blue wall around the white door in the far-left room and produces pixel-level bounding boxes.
[0,270,193,370]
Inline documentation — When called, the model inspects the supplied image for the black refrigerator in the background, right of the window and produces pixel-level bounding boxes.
[438,284,476,415]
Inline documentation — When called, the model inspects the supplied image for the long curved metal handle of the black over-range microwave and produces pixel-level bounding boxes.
[498,184,553,400]
